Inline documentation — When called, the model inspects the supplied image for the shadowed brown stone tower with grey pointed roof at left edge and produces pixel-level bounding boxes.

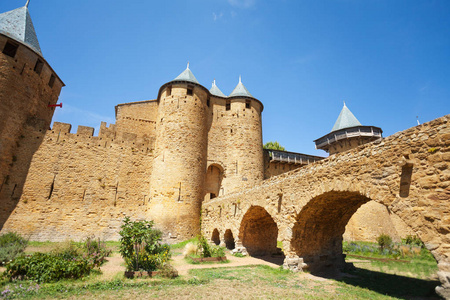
[0,1,64,228]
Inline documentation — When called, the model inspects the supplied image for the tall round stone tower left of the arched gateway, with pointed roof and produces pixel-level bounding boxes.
[149,65,209,239]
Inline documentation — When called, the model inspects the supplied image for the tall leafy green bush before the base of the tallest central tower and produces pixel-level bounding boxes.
[119,217,170,271]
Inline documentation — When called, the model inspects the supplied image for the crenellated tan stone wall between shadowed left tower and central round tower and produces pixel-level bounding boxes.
[2,122,153,241]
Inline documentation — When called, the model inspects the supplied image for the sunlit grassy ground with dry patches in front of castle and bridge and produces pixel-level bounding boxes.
[0,243,439,299]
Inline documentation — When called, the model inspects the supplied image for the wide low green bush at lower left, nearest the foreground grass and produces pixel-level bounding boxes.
[4,252,93,282]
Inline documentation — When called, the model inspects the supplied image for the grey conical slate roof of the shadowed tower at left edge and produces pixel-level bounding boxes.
[0,3,42,55]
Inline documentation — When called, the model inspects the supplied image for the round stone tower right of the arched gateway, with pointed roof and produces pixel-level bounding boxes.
[226,77,264,193]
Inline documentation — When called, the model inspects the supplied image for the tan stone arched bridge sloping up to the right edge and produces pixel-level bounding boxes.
[202,115,450,298]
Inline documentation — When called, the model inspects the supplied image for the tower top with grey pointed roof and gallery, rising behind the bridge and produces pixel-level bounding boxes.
[314,102,383,155]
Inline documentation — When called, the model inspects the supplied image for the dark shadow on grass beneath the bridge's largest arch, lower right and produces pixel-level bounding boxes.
[335,268,441,299]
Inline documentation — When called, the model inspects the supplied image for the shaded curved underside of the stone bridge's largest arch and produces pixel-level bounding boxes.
[291,192,370,273]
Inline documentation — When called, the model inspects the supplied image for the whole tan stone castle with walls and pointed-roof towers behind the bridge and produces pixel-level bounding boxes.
[0,5,412,240]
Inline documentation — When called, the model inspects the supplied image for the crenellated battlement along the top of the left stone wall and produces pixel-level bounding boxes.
[45,122,155,153]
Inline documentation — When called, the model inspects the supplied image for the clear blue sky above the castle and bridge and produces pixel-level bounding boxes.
[0,0,450,156]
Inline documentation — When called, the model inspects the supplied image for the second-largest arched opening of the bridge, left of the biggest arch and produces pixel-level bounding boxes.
[239,206,278,256]
